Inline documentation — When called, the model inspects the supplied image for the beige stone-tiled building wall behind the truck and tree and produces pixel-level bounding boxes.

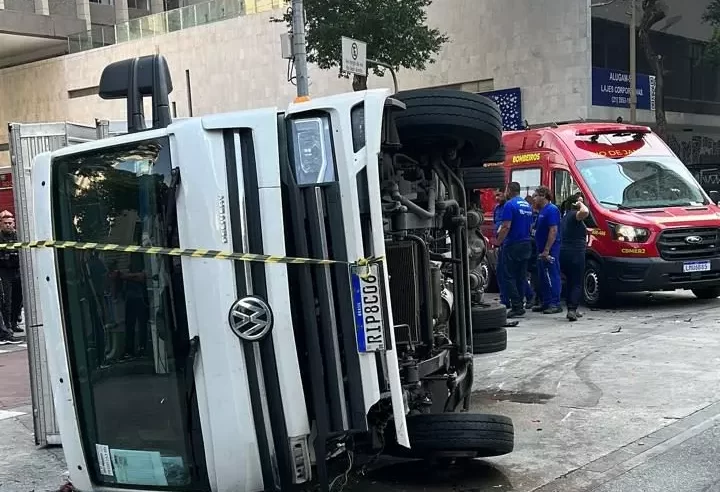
[0,0,590,162]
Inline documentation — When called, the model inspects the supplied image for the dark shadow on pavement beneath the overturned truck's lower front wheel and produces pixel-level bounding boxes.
[352,460,513,492]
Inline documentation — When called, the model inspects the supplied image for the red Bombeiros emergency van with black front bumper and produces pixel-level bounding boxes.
[503,123,720,306]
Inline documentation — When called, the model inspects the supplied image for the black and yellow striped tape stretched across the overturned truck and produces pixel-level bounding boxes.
[0,241,382,266]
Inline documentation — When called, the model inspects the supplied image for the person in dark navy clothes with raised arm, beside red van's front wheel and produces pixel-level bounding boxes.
[560,193,590,321]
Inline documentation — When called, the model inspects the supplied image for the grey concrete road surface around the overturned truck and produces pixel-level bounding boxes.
[0,293,720,492]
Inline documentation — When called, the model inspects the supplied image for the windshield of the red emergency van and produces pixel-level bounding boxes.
[577,156,708,209]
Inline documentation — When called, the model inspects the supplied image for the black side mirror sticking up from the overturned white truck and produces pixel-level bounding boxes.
[99,55,173,133]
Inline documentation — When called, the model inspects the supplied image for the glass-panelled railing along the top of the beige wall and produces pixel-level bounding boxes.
[68,0,285,53]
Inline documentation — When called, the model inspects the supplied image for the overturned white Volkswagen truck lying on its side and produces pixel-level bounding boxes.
[33,55,513,492]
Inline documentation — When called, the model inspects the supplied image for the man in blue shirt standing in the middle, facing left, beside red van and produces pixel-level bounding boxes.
[533,186,562,314]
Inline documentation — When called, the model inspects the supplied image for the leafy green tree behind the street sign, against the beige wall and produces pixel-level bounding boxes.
[284,0,449,91]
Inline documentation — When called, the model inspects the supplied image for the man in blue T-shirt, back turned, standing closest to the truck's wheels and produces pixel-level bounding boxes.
[497,181,532,318]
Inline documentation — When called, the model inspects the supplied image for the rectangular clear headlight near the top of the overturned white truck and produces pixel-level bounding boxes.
[291,116,335,185]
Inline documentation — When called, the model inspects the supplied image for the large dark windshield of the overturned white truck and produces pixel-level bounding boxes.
[52,138,206,490]
